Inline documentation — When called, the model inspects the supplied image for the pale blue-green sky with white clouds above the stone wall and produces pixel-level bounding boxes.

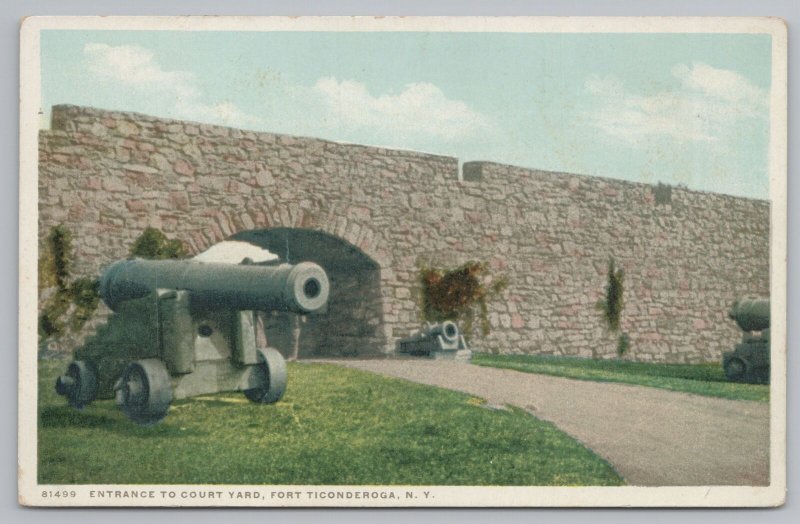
[41,30,771,199]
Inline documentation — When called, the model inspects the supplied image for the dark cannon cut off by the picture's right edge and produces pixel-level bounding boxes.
[722,298,770,384]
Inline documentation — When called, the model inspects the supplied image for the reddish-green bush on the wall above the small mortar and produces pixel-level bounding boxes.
[420,261,508,337]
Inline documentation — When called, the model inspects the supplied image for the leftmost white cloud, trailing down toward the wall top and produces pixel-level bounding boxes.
[83,43,260,127]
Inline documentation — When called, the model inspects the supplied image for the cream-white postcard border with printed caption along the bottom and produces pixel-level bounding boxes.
[18,16,787,507]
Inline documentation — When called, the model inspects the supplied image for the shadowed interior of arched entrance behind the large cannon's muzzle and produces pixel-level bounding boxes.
[228,227,386,358]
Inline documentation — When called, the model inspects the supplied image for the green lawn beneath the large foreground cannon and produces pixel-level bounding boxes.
[38,360,622,486]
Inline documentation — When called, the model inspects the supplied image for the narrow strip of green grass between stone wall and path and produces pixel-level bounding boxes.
[472,353,769,402]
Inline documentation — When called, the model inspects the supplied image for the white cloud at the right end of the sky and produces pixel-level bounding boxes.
[584,62,769,142]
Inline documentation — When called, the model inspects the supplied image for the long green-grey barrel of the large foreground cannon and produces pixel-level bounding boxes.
[100,259,330,313]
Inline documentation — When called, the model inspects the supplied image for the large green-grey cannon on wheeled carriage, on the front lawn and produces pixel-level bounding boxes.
[56,259,329,425]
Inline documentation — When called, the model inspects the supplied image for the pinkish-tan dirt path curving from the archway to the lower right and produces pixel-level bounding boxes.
[312,359,769,486]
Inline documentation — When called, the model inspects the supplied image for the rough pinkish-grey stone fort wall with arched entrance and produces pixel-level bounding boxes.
[38,106,770,362]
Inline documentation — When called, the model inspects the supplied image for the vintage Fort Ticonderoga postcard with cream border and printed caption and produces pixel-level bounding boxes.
[19,17,787,507]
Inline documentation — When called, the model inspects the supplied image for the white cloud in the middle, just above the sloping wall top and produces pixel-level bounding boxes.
[311,77,491,141]
